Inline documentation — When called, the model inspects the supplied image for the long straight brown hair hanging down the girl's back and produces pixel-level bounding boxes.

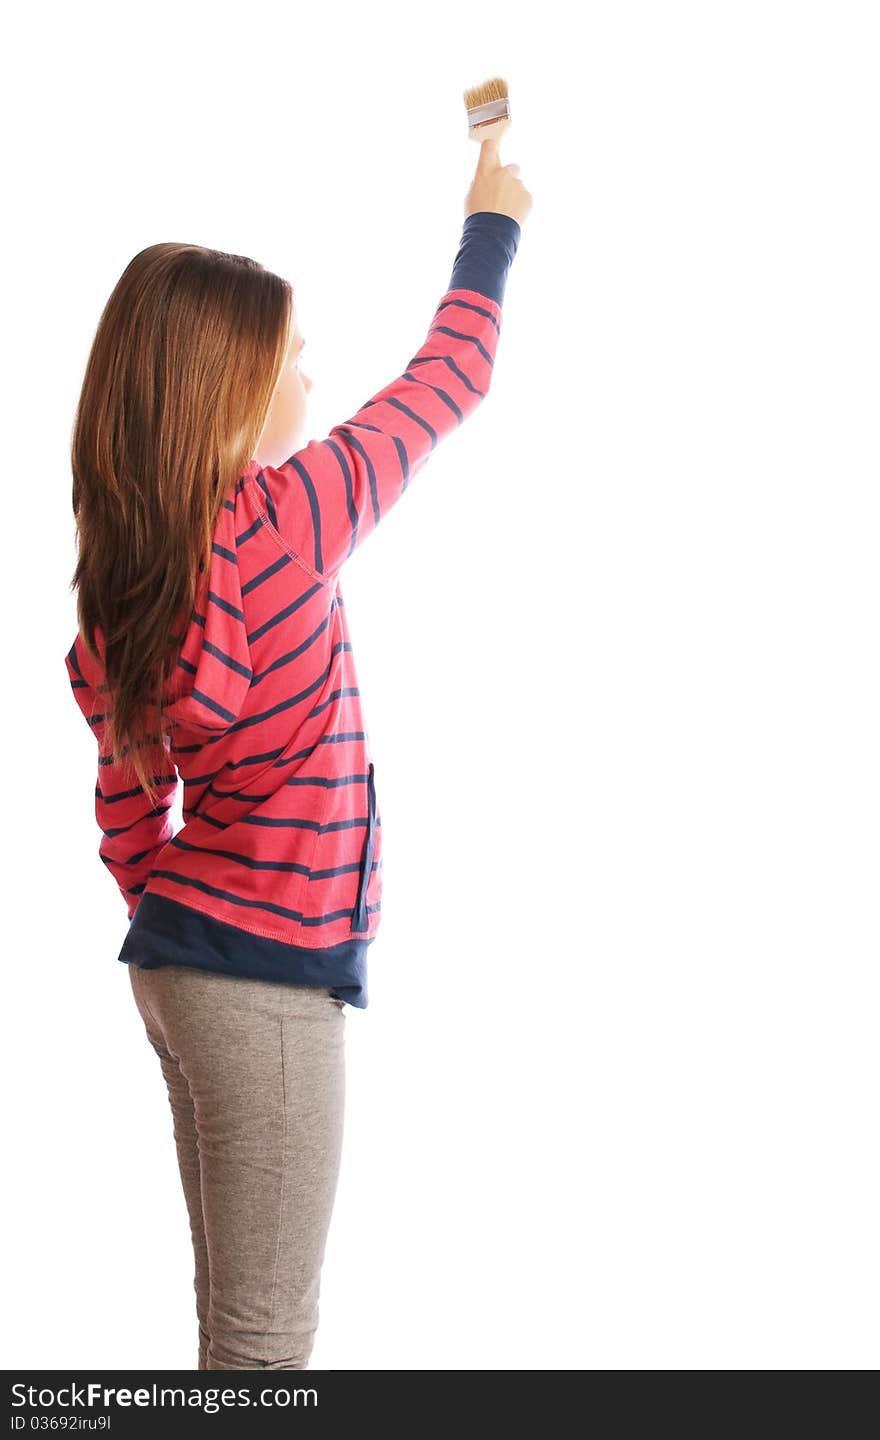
[71,243,294,805]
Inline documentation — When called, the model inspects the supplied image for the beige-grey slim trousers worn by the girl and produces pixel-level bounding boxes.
[128,965,346,1369]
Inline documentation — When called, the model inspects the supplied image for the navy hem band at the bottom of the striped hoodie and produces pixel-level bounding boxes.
[117,890,373,1009]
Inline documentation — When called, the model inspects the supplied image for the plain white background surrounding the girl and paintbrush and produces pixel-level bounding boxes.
[1,0,880,1369]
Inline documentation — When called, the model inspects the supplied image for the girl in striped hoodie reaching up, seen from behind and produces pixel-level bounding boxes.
[66,140,531,1369]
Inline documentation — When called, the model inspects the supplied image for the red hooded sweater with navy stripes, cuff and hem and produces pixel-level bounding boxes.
[65,210,520,1008]
